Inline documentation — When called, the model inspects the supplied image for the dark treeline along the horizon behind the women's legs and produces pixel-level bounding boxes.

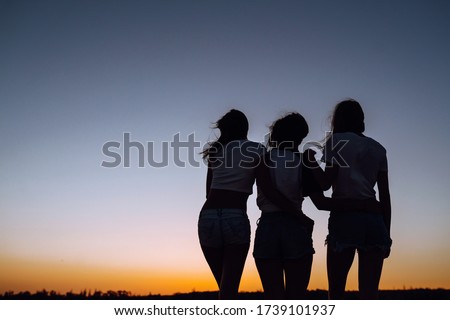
[0,289,450,300]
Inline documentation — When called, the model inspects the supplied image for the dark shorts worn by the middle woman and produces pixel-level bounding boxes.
[253,212,314,260]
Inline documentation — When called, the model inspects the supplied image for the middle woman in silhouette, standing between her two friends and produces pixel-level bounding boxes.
[253,113,321,299]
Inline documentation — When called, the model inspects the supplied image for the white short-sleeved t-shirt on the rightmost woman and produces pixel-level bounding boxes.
[322,132,388,199]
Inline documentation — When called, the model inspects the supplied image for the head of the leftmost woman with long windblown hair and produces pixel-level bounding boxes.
[202,109,248,158]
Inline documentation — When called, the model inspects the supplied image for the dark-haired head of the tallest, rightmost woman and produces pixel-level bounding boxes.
[331,99,365,134]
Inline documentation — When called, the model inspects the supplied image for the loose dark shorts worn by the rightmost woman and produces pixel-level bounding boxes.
[326,212,392,252]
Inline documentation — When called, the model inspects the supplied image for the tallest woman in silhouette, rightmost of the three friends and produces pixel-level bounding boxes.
[308,99,392,299]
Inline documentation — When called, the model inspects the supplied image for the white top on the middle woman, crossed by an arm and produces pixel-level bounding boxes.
[256,149,303,212]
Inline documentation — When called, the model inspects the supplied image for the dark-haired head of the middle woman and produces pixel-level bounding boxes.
[268,112,309,149]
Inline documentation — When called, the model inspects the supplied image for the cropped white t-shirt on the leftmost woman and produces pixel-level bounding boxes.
[210,140,264,194]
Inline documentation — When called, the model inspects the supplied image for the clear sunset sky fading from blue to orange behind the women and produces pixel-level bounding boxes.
[0,0,450,294]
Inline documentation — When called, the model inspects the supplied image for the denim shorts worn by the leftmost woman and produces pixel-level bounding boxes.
[198,209,250,248]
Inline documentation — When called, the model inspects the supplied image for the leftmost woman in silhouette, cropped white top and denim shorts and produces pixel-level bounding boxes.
[198,109,264,299]
